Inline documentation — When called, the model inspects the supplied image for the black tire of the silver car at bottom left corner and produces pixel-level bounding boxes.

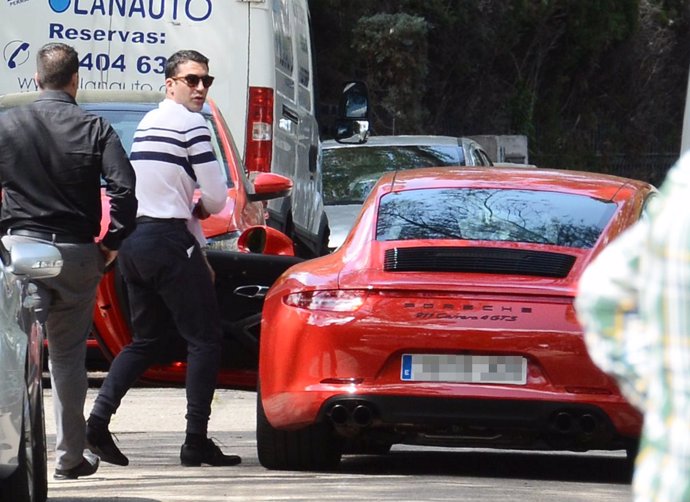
[0,397,48,502]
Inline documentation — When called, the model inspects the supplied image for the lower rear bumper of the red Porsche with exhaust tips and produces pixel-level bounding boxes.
[264,385,642,451]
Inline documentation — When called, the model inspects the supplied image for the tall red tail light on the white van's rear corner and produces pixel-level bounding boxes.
[244,87,273,172]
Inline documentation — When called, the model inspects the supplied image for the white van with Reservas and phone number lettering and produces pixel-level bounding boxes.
[0,0,329,256]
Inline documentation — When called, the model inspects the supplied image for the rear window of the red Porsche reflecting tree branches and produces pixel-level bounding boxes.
[376,188,616,248]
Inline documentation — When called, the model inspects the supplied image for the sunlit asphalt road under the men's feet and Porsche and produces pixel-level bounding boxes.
[45,388,631,502]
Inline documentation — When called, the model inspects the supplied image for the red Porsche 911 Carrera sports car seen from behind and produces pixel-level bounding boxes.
[257,167,656,470]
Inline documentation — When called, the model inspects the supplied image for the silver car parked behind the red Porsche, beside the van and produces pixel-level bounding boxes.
[321,135,493,250]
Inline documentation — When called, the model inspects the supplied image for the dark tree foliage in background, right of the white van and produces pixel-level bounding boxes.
[310,0,690,182]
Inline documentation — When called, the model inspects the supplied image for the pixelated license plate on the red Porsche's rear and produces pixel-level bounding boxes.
[400,354,527,385]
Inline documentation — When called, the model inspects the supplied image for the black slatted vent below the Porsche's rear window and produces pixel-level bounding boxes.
[383,247,575,277]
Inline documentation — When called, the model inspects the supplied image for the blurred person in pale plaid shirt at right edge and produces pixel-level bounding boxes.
[575,154,690,502]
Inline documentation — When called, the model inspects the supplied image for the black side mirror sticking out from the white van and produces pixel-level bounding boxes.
[335,80,369,144]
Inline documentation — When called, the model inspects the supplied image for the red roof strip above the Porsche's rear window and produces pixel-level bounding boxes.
[379,166,655,199]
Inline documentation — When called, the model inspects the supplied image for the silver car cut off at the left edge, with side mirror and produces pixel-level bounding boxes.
[0,242,62,502]
